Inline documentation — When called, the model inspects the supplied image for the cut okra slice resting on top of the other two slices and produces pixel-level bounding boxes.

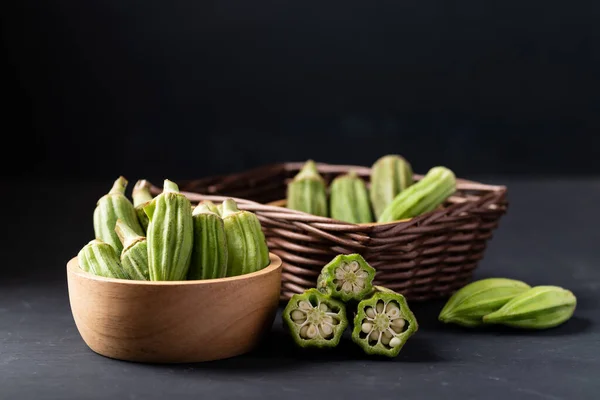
[317,254,375,302]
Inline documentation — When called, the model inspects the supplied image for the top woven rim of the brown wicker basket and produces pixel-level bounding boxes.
[148,162,508,231]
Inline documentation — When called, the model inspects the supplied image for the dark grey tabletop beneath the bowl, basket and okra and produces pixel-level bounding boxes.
[0,178,600,400]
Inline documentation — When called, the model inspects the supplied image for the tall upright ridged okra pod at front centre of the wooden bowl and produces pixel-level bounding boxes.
[144,179,194,281]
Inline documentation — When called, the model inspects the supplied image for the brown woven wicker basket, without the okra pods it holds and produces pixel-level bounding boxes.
[153,163,507,300]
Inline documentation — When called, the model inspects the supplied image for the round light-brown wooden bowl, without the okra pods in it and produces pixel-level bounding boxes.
[67,254,281,363]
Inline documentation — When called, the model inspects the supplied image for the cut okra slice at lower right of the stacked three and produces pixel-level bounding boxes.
[352,286,418,357]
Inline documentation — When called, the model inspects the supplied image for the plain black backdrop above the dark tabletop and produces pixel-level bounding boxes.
[2,0,600,179]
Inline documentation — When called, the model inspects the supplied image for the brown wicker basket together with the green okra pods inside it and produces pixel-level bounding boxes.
[182,155,507,300]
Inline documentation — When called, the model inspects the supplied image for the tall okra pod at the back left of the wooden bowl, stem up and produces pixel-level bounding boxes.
[94,176,144,254]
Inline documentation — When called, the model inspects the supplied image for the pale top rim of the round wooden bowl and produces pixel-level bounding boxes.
[67,252,283,286]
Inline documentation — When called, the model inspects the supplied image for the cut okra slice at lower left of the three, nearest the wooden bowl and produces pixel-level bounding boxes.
[283,289,348,348]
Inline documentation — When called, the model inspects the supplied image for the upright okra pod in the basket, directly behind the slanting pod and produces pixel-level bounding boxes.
[370,154,413,219]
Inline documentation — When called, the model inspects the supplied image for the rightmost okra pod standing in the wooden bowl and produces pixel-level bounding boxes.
[221,199,270,276]
